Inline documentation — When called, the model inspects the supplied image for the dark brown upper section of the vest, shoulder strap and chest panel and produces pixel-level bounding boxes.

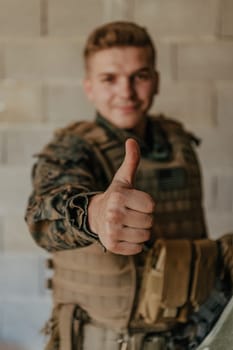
[83,117,206,239]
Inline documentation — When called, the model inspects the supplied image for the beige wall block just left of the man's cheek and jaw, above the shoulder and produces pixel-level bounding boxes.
[47,84,94,123]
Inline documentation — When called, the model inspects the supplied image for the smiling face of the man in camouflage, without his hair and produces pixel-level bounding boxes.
[84,47,158,133]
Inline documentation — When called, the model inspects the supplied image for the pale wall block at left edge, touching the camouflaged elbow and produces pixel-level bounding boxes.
[3,214,44,255]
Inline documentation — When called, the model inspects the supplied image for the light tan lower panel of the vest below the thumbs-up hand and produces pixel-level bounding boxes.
[52,244,136,330]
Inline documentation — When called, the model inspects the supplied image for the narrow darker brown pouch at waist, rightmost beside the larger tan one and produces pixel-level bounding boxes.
[190,239,218,307]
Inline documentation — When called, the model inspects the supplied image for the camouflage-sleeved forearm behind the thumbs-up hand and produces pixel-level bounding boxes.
[25,191,101,251]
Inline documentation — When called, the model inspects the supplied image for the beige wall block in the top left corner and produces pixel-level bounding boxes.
[0,0,40,37]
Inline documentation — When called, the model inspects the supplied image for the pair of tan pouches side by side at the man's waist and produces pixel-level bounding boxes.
[136,239,218,325]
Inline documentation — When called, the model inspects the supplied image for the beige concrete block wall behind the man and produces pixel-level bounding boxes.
[0,0,233,350]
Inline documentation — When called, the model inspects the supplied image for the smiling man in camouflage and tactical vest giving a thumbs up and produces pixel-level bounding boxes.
[26,22,232,350]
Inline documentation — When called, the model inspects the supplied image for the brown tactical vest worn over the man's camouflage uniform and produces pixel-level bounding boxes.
[48,117,206,330]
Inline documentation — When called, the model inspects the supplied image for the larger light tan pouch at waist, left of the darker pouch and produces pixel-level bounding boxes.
[136,240,192,324]
